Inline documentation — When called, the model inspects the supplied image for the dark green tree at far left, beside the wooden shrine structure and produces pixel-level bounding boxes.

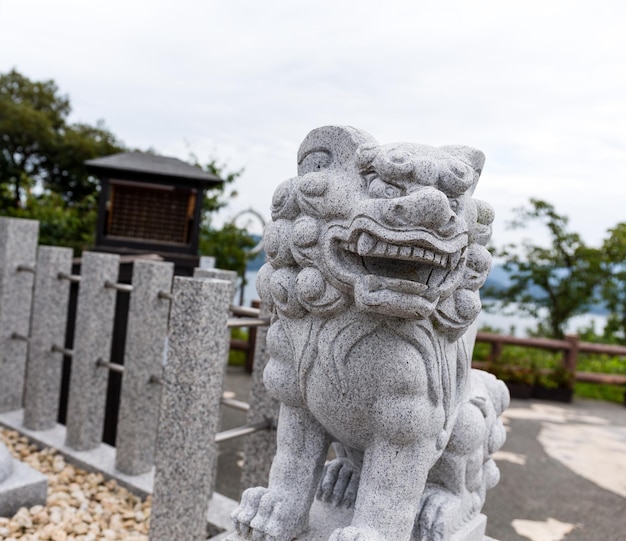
[0,70,124,248]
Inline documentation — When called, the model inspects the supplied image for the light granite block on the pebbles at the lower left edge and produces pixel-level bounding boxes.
[0,454,48,517]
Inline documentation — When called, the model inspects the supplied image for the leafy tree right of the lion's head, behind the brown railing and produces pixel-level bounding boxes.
[488,199,602,338]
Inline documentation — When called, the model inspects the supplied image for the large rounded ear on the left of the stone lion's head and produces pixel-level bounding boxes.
[298,126,377,175]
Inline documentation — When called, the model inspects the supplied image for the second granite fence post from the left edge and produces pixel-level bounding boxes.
[24,246,72,430]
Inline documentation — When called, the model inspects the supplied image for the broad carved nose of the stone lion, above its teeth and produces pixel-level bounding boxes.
[381,187,454,231]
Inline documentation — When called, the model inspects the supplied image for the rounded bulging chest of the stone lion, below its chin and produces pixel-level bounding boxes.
[283,318,446,448]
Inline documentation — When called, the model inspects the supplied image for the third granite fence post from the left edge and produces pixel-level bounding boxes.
[66,252,119,451]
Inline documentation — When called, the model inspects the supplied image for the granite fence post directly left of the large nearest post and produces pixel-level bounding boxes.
[115,260,174,475]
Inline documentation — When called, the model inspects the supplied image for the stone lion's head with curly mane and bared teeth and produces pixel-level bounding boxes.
[257,126,494,336]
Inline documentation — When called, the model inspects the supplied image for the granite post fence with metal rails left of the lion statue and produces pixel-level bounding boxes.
[0,217,277,541]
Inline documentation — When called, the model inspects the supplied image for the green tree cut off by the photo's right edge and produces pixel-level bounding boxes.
[601,222,626,344]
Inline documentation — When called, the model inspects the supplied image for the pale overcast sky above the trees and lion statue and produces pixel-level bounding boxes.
[0,0,626,245]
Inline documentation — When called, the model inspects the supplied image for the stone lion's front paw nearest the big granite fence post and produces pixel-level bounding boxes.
[231,487,306,541]
